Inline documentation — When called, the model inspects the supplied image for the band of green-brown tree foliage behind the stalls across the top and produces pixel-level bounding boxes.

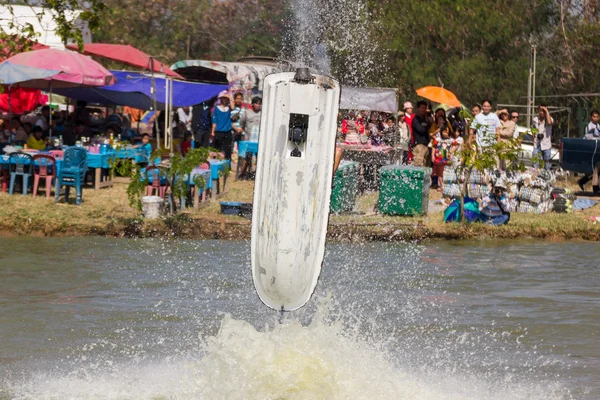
[0,0,600,114]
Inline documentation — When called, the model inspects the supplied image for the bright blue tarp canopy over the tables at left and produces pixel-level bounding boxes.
[54,71,229,110]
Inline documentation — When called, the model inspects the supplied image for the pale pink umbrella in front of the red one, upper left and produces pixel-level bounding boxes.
[6,49,115,89]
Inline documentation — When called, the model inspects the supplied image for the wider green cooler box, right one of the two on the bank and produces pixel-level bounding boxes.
[377,165,431,215]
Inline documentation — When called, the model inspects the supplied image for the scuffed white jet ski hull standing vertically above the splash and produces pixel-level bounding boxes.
[251,72,340,311]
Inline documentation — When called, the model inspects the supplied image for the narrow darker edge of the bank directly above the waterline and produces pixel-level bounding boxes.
[0,214,600,242]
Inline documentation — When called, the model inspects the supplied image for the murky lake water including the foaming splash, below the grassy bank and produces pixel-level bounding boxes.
[0,238,600,400]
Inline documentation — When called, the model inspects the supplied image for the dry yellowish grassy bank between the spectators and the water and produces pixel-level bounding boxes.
[0,177,600,241]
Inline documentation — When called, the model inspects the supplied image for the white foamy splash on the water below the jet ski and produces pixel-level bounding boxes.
[5,313,565,400]
